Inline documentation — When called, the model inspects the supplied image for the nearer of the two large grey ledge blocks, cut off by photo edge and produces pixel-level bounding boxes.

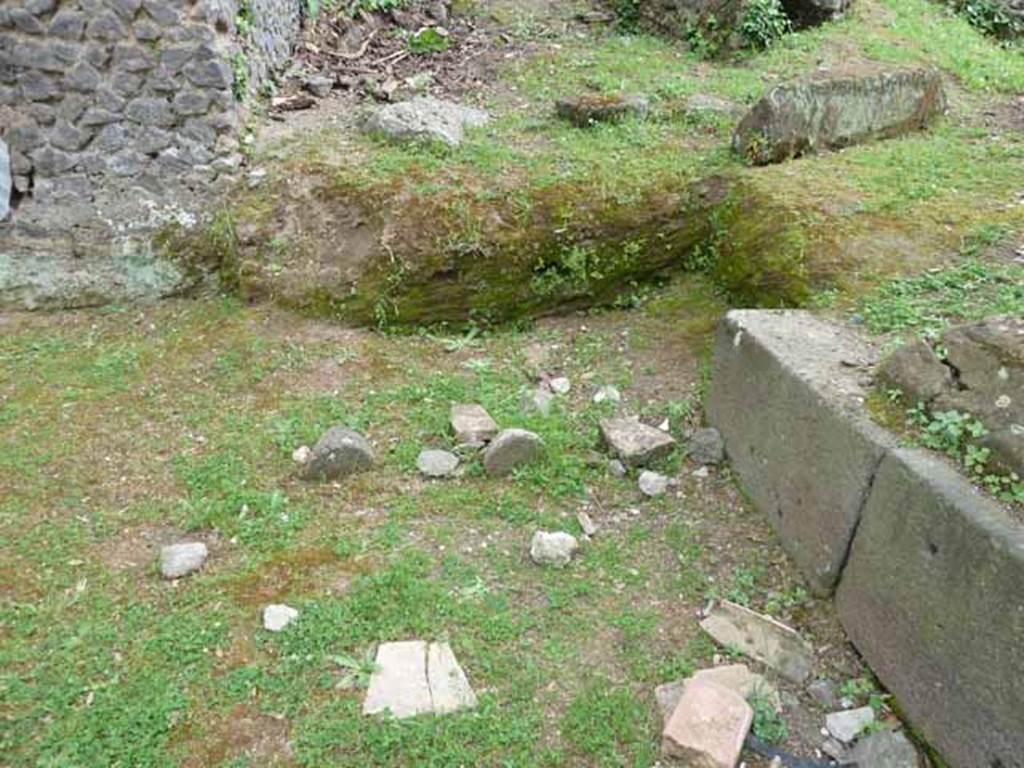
[837,450,1024,768]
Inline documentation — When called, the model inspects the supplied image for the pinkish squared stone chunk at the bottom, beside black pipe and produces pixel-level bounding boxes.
[662,680,754,768]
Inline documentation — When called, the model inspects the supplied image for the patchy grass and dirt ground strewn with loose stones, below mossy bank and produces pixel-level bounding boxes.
[0,280,917,766]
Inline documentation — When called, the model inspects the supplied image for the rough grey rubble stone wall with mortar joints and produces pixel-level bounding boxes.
[0,0,301,307]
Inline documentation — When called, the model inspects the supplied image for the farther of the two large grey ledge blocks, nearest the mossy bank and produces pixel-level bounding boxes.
[708,310,893,594]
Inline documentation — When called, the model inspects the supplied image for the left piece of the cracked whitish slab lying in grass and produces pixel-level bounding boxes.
[362,640,433,719]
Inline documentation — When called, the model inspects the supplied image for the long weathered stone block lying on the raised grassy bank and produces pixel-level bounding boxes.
[733,70,946,165]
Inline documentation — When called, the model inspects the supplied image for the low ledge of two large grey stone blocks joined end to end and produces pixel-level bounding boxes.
[709,310,1024,768]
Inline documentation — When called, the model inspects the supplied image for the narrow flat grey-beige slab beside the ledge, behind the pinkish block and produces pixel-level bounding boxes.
[700,600,814,684]
